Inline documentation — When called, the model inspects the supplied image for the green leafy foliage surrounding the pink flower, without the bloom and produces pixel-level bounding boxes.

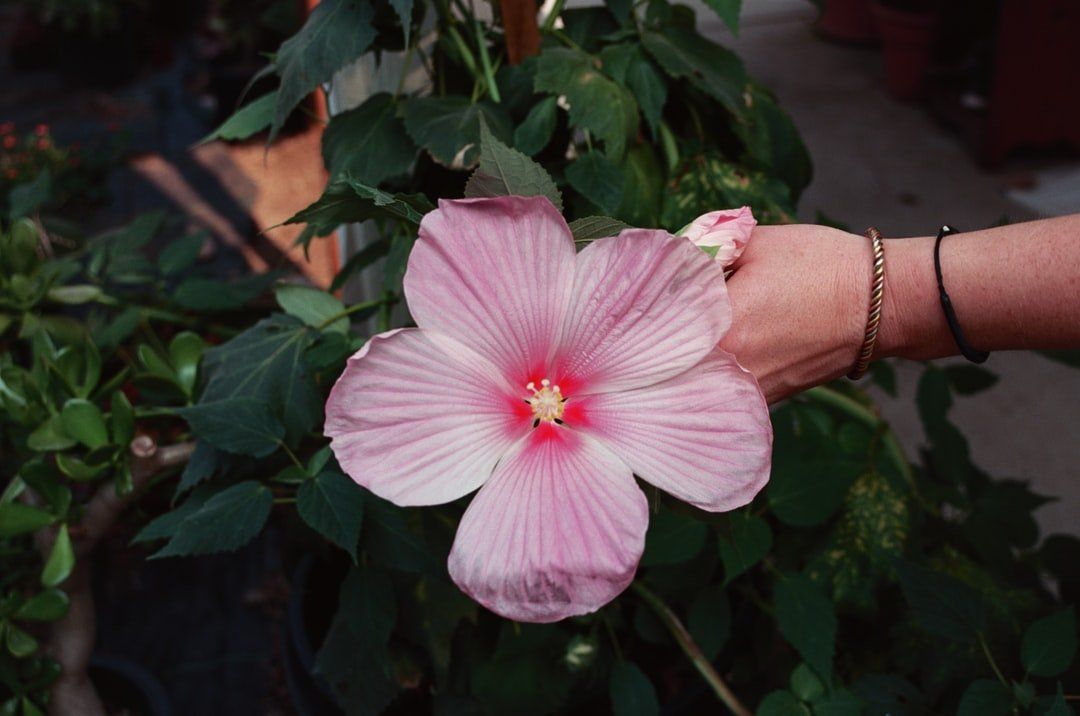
[0,0,1080,716]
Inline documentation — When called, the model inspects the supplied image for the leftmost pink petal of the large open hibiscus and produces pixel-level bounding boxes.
[325,328,531,505]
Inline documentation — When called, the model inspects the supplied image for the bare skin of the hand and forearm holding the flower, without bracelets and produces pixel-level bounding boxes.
[720,214,1080,403]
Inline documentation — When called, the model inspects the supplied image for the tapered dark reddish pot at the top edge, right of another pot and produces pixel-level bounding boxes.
[873,0,937,102]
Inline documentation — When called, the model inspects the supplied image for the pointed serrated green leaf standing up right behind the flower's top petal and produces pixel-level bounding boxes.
[465,116,563,211]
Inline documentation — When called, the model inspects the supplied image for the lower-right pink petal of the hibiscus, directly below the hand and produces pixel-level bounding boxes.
[584,348,772,512]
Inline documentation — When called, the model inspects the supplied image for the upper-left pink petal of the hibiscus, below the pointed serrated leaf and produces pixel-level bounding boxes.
[405,197,575,386]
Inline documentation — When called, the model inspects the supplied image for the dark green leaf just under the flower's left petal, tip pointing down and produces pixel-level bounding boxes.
[296,471,364,562]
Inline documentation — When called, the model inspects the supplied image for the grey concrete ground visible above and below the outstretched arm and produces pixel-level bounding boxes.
[698,0,1080,535]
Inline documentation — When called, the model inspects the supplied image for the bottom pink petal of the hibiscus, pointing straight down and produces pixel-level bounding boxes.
[449,423,648,622]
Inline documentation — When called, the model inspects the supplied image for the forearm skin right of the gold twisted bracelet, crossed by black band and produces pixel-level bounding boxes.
[875,215,1080,360]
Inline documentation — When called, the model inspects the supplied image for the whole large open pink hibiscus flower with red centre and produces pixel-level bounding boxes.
[326,197,772,622]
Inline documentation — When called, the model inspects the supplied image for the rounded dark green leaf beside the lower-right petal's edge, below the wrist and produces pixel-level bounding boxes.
[766,456,862,527]
